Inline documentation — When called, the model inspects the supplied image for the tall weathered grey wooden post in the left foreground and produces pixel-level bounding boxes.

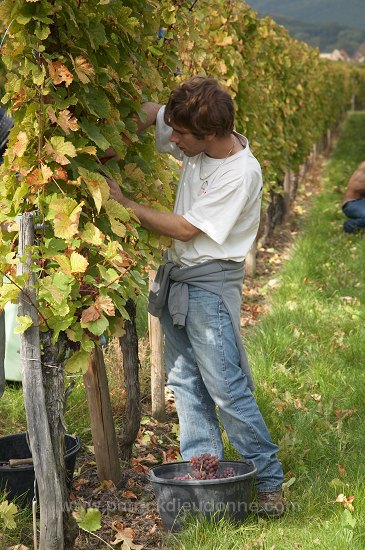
[19,213,66,550]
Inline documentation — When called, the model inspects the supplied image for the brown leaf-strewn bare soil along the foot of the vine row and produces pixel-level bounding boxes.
[71,157,324,550]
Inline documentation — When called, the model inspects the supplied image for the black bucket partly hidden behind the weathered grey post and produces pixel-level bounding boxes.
[0,433,80,507]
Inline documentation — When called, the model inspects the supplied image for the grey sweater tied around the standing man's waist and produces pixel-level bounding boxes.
[148,260,254,390]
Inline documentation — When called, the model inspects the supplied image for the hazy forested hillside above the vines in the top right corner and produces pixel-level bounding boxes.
[247,0,365,56]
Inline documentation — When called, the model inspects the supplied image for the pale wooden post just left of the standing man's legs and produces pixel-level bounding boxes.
[148,270,166,420]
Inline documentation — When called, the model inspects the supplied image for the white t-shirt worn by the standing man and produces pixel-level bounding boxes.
[156,107,262,265]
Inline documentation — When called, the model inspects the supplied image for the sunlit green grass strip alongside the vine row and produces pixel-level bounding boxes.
[167,113,365,550]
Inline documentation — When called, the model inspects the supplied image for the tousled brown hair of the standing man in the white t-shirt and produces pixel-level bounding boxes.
[164,76,234,139]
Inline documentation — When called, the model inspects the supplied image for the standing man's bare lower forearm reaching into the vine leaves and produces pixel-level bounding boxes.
[107,179,201,242]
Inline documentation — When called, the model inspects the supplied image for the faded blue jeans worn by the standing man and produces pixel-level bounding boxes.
[161,285,284,491]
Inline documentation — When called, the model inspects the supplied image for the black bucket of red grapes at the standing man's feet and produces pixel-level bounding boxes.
[150,460,256,531]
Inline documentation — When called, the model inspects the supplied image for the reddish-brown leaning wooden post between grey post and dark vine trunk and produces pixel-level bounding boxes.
[84,346,121,486]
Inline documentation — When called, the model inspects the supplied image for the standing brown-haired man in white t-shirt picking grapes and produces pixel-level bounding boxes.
[105,77,283,516]
